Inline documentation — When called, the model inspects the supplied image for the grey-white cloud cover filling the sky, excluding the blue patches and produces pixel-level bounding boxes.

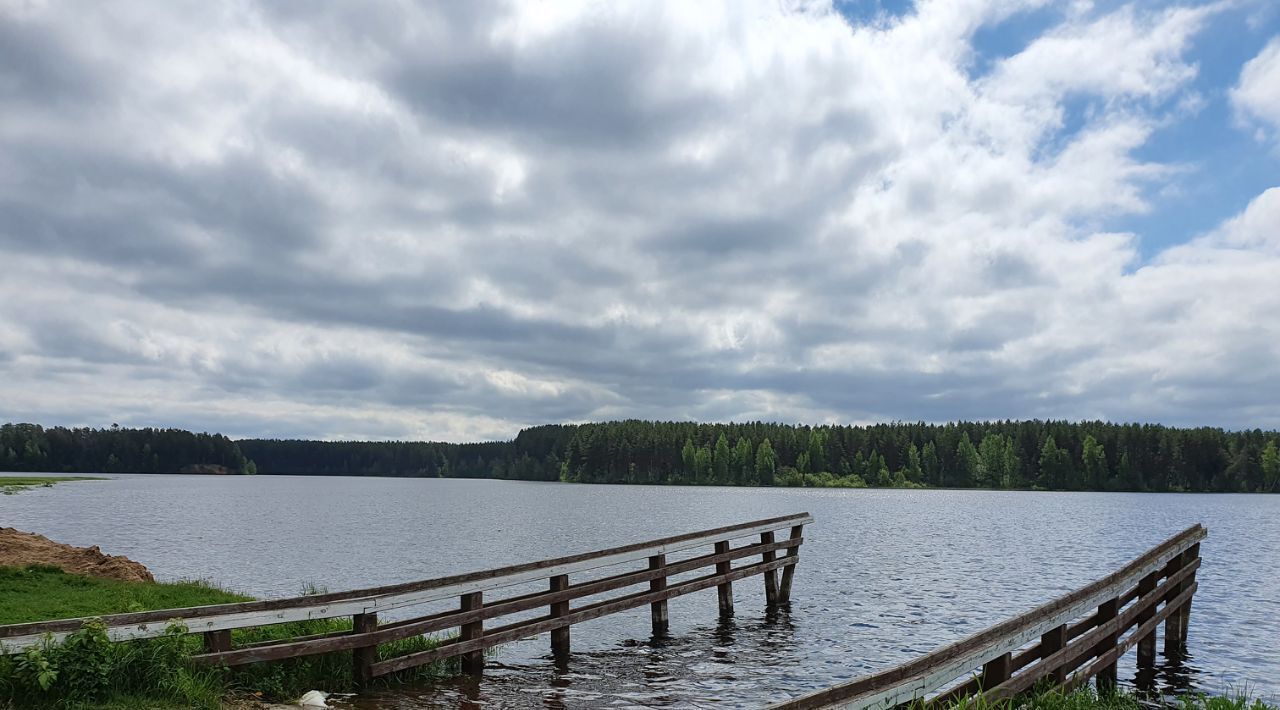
[0,3,1280,439]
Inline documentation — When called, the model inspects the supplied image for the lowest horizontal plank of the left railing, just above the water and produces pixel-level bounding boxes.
[371,556,797,677]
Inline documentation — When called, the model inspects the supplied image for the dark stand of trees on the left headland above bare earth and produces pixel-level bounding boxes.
[0,423,253,473]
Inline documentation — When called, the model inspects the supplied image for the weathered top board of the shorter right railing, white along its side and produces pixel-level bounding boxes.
[771,525,1208,710]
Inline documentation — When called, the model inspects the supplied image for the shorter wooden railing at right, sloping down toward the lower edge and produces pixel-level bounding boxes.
[773,525,1207,710]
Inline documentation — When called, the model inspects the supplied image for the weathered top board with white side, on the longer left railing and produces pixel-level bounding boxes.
[0,513,813,654]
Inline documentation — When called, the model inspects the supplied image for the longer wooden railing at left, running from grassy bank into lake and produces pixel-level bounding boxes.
[0,513,813,681]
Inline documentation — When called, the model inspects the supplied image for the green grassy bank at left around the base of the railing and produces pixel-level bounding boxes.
[0,565,454,707]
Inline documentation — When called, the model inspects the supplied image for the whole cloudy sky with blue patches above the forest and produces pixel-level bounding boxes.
[0,0,1280,441]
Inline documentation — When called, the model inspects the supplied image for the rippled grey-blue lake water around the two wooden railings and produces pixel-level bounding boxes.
[0,476,1280,707]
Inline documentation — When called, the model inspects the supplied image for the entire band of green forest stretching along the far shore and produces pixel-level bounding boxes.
[0,421,1280,493]
